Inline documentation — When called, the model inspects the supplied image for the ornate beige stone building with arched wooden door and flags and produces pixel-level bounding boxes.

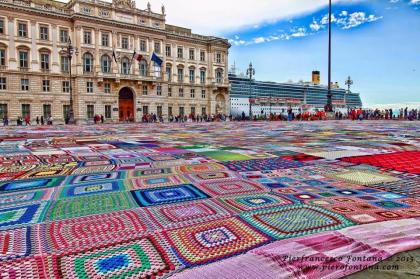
[0,0,230,123]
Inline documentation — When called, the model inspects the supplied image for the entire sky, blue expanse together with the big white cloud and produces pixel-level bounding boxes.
[147,0,420,107]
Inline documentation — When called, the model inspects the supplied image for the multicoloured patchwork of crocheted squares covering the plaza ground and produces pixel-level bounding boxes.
[0,121,420,278]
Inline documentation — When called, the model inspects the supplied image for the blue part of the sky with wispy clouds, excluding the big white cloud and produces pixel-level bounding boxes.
[221,0,420,105]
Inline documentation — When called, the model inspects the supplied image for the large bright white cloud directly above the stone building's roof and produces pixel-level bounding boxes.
[143,0,352,35]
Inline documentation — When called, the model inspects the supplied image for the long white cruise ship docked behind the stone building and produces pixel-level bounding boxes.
[229,73,362,116]
